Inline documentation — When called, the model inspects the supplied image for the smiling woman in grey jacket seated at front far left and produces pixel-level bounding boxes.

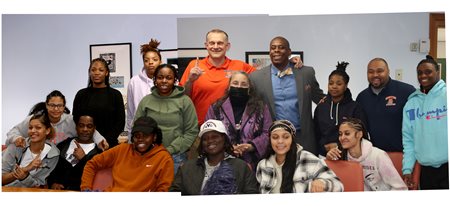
[2,112,59,187]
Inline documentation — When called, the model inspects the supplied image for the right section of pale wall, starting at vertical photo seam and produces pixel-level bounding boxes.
[178,13,429,98]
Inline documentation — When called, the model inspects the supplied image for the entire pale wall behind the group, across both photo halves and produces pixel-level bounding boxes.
[1,13,428,143]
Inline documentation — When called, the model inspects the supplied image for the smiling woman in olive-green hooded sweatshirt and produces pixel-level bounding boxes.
[135,64,198,173]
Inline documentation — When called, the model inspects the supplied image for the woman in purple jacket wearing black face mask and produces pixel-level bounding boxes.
[205,72,272,171]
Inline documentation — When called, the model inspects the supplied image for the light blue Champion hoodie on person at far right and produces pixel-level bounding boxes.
[402,80,448,174]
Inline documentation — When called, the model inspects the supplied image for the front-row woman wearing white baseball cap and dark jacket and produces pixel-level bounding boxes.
[169,119,258,195]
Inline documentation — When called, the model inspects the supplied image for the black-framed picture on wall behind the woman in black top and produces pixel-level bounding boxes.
[89,43,132,96]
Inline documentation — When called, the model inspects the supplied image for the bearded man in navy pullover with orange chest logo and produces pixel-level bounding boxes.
[356,58,415,152]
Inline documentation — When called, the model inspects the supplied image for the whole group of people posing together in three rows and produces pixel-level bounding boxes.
[2,29,448,195]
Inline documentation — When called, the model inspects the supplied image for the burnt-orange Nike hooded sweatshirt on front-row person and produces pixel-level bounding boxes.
[81,144,174,192]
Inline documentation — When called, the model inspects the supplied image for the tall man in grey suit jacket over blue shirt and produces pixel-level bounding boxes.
[250,36,325,155]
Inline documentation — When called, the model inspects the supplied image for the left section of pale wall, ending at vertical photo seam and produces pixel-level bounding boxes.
[1,14,246,143]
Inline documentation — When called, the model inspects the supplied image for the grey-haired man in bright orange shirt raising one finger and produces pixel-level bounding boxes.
[179,29,255,125]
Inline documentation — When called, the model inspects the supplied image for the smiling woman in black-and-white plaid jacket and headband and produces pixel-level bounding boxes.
[256,120,344,194]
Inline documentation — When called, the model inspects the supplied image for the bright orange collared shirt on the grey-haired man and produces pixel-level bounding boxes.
[179,56,255,125]
